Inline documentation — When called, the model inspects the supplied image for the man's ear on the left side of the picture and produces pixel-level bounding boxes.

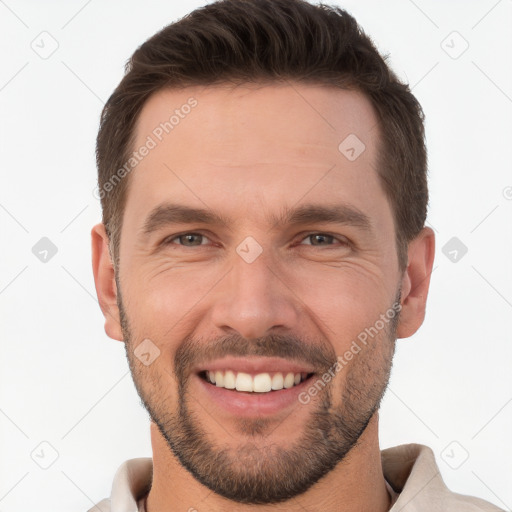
[91,223,123,341]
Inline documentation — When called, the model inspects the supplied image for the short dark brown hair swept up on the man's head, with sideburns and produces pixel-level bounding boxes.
[96,0,428,271]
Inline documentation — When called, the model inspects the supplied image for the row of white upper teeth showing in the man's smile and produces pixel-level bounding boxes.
[206,370,307,393]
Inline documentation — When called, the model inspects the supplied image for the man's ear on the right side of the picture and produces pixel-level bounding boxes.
[397,227,435,338]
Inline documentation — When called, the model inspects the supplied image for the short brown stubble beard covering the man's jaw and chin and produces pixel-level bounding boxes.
[118,286,400,505]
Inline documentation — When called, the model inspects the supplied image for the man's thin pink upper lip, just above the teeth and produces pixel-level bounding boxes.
[196,356,314,374]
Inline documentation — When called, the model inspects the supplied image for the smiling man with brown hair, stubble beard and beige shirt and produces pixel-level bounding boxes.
[91,0,499,512]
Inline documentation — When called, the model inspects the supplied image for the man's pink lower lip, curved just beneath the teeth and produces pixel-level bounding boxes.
[195,375,312,417]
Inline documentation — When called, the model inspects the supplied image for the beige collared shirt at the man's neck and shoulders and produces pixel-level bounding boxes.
[88,444,503,512]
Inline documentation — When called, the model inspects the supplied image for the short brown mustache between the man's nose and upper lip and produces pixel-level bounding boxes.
[174,334,337,382]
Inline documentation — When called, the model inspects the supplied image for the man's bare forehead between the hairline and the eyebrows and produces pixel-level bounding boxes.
[125,83,385,234]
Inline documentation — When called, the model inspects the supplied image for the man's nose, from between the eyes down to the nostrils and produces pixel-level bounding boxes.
[211,248,303,339]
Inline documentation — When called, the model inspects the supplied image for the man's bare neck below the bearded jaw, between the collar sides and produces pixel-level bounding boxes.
[146,412,390,512]
